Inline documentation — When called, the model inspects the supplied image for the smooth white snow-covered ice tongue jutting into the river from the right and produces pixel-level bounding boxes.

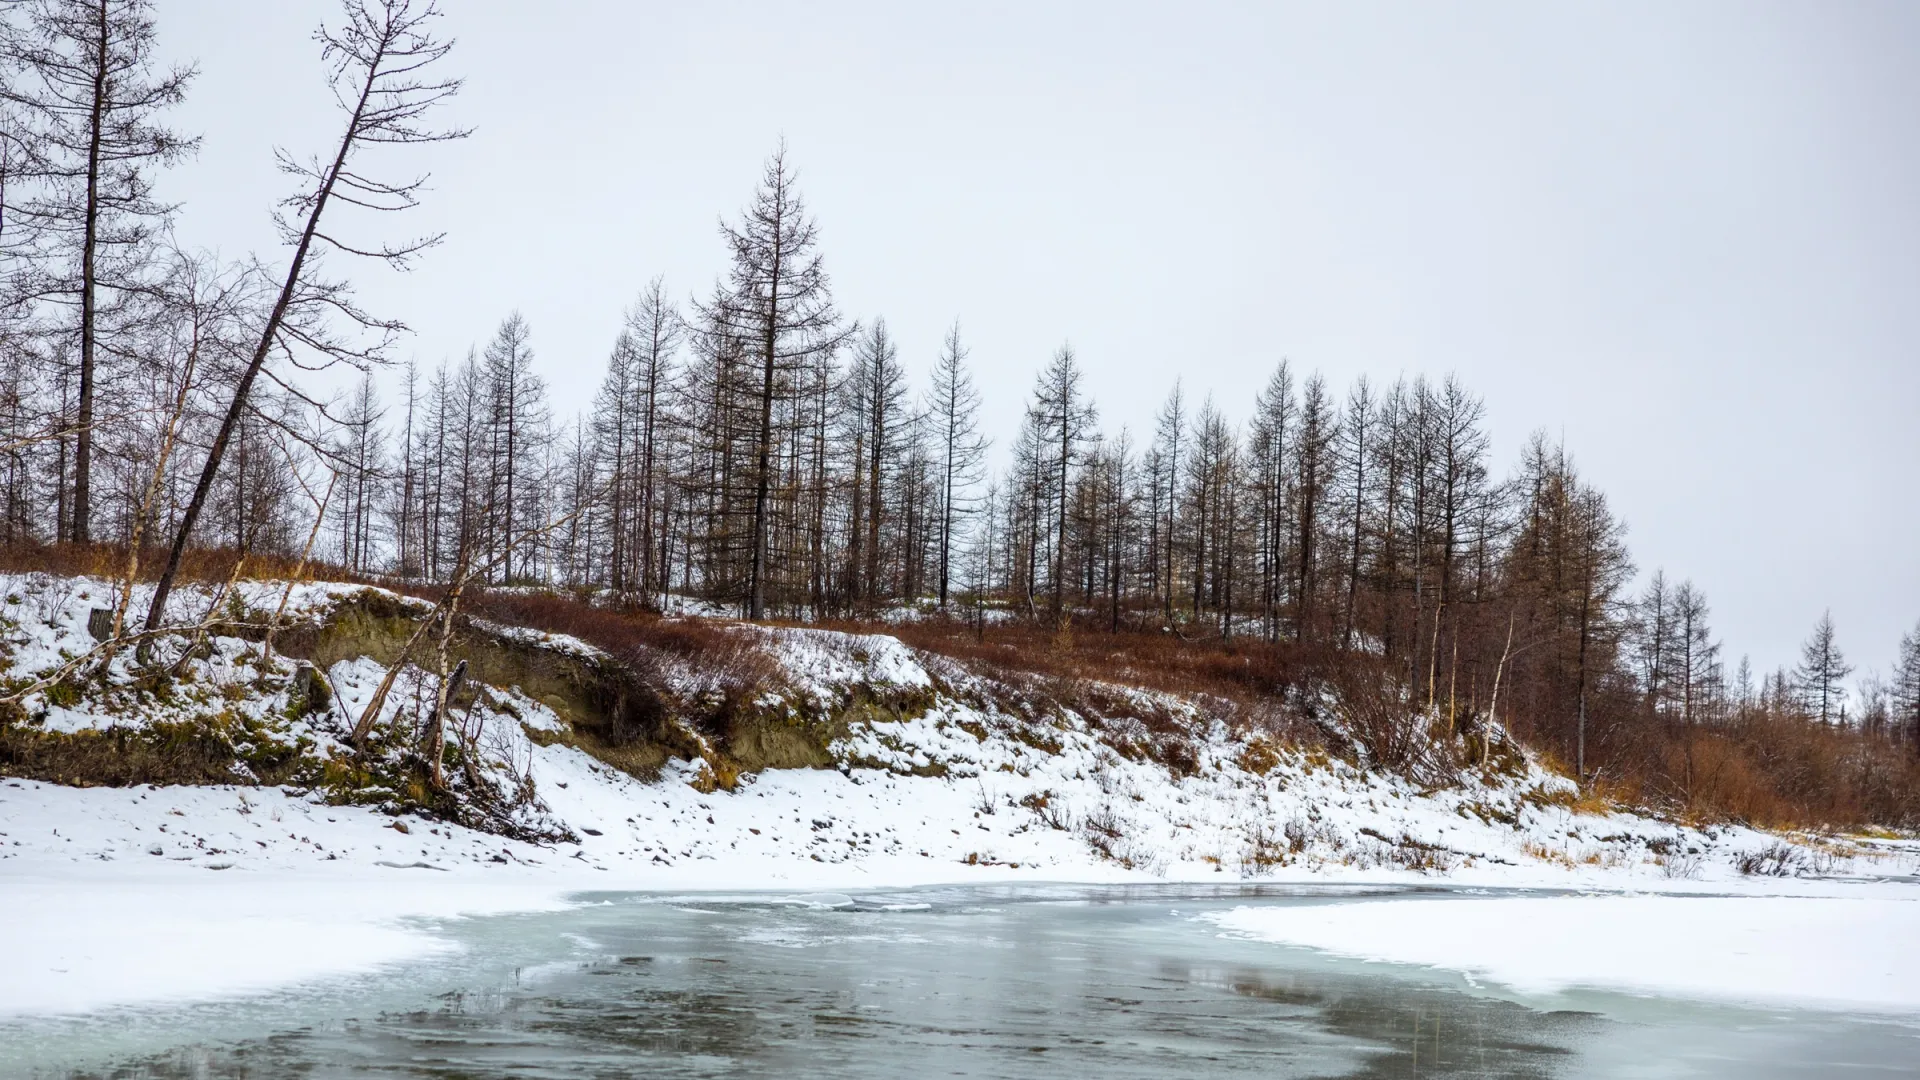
[1204,890,1920,1015]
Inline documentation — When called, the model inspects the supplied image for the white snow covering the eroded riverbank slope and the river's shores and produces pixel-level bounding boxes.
[0,575,1920,1015]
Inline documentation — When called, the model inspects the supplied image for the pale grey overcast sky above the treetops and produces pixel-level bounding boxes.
[157,0,1920,671]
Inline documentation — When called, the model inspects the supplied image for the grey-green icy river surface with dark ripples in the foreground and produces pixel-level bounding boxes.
[0,886,1920,1080]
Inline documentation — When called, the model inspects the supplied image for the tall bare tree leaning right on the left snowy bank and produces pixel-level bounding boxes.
[146,0,467,630]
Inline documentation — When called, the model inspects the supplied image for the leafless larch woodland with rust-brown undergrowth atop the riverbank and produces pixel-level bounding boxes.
[0,0,1920,826]
